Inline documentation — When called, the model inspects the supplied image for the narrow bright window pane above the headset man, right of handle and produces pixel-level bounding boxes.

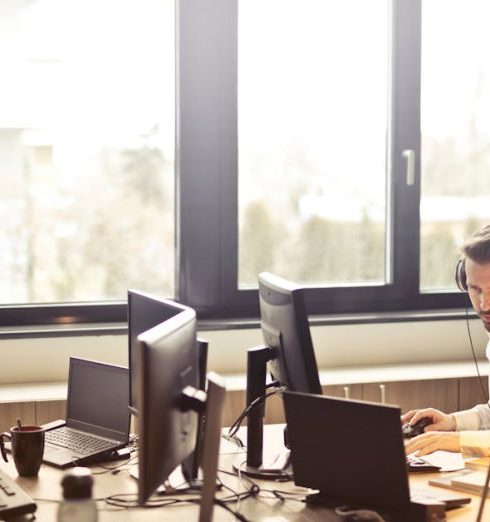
[420,0,490,291]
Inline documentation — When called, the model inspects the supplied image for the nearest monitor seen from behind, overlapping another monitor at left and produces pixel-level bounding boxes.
[136,308,205,504]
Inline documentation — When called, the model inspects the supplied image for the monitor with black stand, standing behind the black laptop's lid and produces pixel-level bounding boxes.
[242,272,322,476]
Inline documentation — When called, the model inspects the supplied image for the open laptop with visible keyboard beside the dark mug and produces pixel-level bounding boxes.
[43,357,130,468]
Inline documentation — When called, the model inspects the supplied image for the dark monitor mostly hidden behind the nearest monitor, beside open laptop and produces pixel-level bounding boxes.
[128,290,185,408]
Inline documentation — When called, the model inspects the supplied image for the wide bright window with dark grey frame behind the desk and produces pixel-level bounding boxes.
[0,0,490,322]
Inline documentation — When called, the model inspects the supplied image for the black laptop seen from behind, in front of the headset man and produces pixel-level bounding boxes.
[283,392,471,520]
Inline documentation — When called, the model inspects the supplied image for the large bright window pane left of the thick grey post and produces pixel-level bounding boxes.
[0,0,175,303]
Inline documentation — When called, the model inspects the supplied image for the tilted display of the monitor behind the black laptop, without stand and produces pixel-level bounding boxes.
[259,272,322,394]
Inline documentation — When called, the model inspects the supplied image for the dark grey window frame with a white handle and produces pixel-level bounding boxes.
[0,0,470,326]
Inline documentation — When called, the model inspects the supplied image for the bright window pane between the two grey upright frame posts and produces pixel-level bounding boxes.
[238,0,389,286]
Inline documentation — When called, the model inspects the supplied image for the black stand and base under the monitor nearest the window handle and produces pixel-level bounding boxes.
[233,346,292,480]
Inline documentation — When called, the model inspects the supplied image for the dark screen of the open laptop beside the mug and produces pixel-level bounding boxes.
[66,357,130,441]
